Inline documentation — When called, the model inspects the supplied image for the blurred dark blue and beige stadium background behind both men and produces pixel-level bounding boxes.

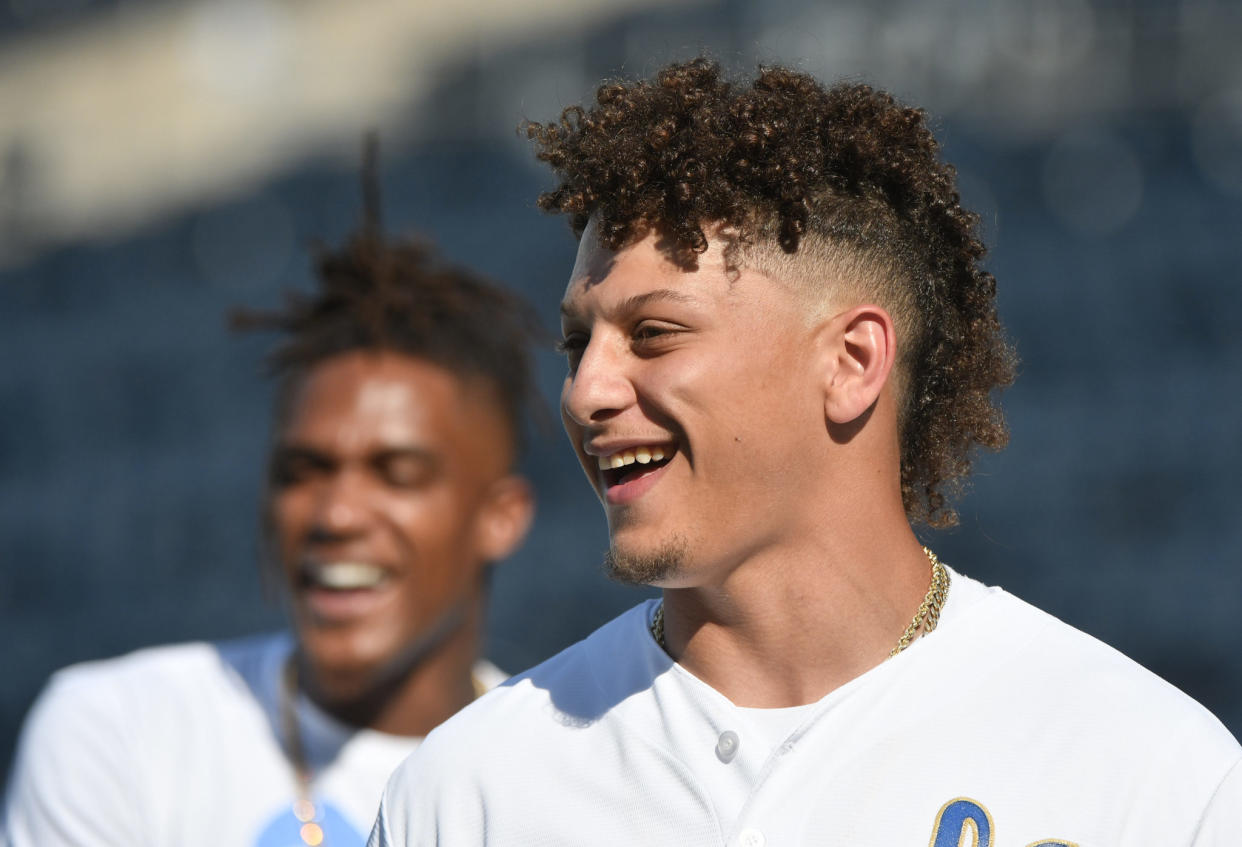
[0,0,1242,763]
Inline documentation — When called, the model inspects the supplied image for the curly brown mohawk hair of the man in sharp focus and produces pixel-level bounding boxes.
[525,58,1016,527]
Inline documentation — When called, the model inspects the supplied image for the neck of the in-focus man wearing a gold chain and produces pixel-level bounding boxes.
[664,523,932,708]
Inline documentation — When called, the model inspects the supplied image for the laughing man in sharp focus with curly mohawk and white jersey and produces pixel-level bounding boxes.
[371,60,1242,847]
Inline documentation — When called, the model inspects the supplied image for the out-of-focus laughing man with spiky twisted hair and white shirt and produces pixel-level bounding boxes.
[0,211,535,847]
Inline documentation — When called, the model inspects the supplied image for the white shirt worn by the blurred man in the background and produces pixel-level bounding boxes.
[8,635,503,847]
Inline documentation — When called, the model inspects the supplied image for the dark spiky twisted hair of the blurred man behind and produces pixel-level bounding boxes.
[231,139,544,451]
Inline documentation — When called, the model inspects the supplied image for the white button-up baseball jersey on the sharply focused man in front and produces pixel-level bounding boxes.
[370,574,1242,847]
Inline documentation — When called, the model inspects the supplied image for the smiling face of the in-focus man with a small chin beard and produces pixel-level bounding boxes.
[561,229,823,586]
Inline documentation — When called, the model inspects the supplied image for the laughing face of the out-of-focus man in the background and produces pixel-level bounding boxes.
[268,351,520,695]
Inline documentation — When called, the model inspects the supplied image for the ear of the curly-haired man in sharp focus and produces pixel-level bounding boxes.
[821,304,897,425]
